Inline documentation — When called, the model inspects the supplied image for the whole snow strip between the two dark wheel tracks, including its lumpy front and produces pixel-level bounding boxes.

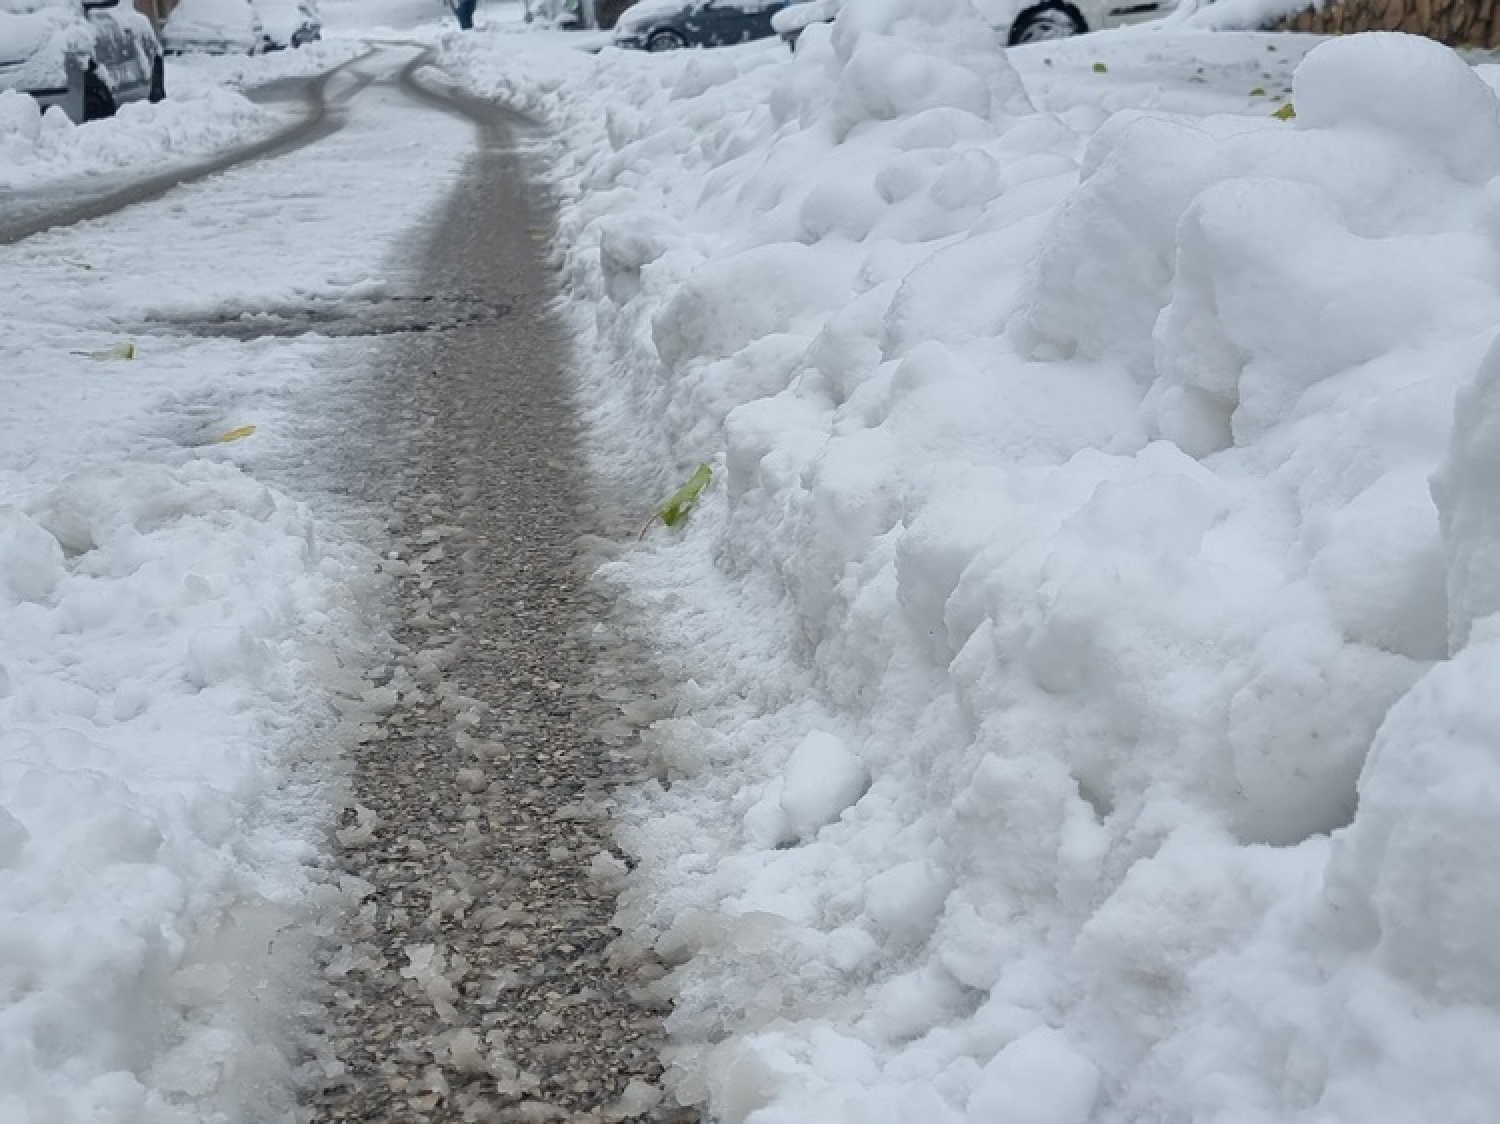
[0,30,473,1124]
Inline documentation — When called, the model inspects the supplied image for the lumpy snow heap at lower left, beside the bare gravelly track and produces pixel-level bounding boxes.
[0,453,363,1124]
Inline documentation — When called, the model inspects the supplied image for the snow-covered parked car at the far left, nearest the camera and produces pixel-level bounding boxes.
[0,0,167,122]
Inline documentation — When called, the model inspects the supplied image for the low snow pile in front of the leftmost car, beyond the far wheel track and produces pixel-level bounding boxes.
[0,89,285,191]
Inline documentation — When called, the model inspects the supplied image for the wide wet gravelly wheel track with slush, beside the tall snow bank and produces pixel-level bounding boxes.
[294,74,696,1122]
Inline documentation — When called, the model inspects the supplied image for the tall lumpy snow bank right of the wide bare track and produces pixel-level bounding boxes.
[447,17,1500,1124]
